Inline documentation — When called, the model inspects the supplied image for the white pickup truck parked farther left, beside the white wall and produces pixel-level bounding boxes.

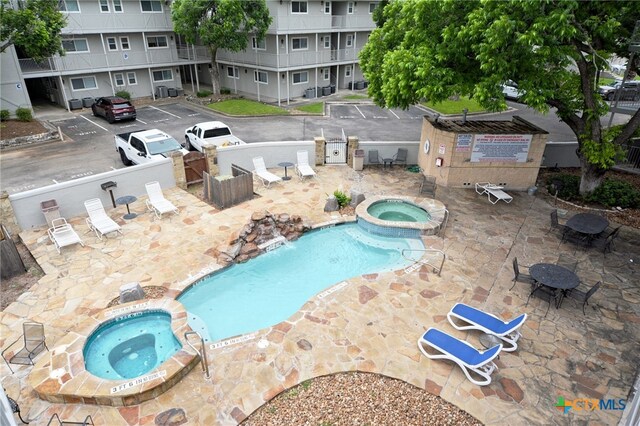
[115,129,188,166]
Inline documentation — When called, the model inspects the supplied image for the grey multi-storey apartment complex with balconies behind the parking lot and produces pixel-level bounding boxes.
[0,0,378,112]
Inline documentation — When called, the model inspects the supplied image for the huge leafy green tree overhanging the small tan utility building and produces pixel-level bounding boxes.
[360,0,640,194]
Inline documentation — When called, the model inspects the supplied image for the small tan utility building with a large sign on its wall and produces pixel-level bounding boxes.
[418,116,548,190]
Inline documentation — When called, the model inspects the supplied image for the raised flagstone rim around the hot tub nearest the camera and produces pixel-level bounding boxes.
[28,298,200,406]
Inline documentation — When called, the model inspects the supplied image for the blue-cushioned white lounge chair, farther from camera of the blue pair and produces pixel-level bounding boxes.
[447,303,527,352]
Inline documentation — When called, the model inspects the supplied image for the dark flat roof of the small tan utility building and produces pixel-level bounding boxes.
[425,115,549,135]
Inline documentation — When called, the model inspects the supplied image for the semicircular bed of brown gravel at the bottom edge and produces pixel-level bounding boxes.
[241,372,482,426]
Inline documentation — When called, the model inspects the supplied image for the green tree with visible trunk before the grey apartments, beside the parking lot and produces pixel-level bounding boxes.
[171,0,271,94]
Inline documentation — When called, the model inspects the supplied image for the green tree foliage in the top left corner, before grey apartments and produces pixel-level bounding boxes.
[0,0,67,60]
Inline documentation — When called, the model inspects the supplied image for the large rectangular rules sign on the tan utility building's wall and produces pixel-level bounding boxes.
[471,135,533,163]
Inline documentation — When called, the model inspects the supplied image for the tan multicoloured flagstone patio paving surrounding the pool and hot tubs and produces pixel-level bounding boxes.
[0,166,640,425]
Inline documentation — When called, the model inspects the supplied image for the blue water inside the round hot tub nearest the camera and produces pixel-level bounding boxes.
[83,311,182,379]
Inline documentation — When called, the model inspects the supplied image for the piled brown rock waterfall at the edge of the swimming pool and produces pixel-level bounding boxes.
[218,211,311,264]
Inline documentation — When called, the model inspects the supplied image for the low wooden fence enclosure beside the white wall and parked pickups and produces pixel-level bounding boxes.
[204,164,253,209]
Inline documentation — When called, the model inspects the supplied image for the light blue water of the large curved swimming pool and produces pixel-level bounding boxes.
[178,224,424,341]
